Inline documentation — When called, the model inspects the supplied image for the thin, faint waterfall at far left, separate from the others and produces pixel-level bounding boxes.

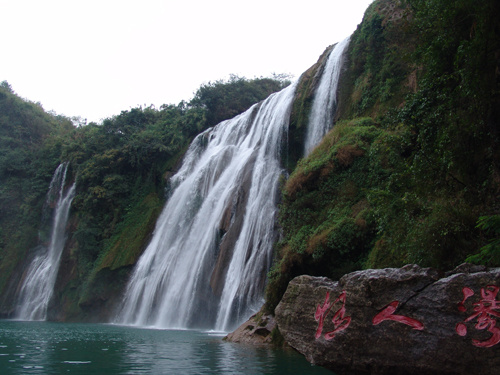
[16,163,75,320]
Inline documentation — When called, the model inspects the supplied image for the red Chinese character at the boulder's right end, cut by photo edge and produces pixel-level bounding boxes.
[455,285,500,348]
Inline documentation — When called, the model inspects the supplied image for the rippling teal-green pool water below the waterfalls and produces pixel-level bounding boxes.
[0,320,332,375]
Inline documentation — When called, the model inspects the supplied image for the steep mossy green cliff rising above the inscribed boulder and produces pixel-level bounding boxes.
[266,0,500,311]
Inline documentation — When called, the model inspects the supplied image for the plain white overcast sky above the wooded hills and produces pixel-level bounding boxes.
[0,0,372,122]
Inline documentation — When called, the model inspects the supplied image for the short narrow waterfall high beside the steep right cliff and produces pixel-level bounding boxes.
[304,38,349,156]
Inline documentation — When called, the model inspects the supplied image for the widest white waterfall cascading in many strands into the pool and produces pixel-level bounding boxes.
[115,84,295,330]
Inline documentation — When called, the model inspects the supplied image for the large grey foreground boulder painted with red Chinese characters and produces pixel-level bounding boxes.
[275,265,500,375]
